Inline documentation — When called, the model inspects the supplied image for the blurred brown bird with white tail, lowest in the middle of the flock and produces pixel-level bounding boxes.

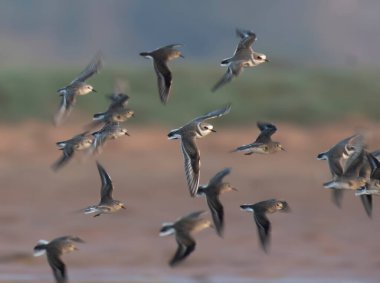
[160,211,211,267]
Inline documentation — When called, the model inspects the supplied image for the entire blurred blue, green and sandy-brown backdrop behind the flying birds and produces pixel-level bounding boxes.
[0,0,380,283]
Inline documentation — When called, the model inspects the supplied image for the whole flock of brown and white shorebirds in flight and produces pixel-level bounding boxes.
[30,29,380,283]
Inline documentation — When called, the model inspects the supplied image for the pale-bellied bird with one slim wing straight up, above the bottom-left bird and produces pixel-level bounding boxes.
[84,162,125,217]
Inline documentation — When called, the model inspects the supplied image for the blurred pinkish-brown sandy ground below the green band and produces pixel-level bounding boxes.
[0,121,380,283]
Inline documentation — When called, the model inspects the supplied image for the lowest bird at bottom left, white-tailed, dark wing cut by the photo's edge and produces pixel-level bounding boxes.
[34,236,84,283]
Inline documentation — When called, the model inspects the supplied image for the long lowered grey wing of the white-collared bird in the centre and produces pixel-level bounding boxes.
[181,137,200,197]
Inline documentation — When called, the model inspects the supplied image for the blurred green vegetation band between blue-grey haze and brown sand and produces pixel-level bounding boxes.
[0,65,380,126]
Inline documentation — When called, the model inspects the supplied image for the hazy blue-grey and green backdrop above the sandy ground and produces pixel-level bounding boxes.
[0,0,380,124]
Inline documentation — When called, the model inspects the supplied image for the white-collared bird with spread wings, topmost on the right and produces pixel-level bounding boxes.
[212,29,269,92]
